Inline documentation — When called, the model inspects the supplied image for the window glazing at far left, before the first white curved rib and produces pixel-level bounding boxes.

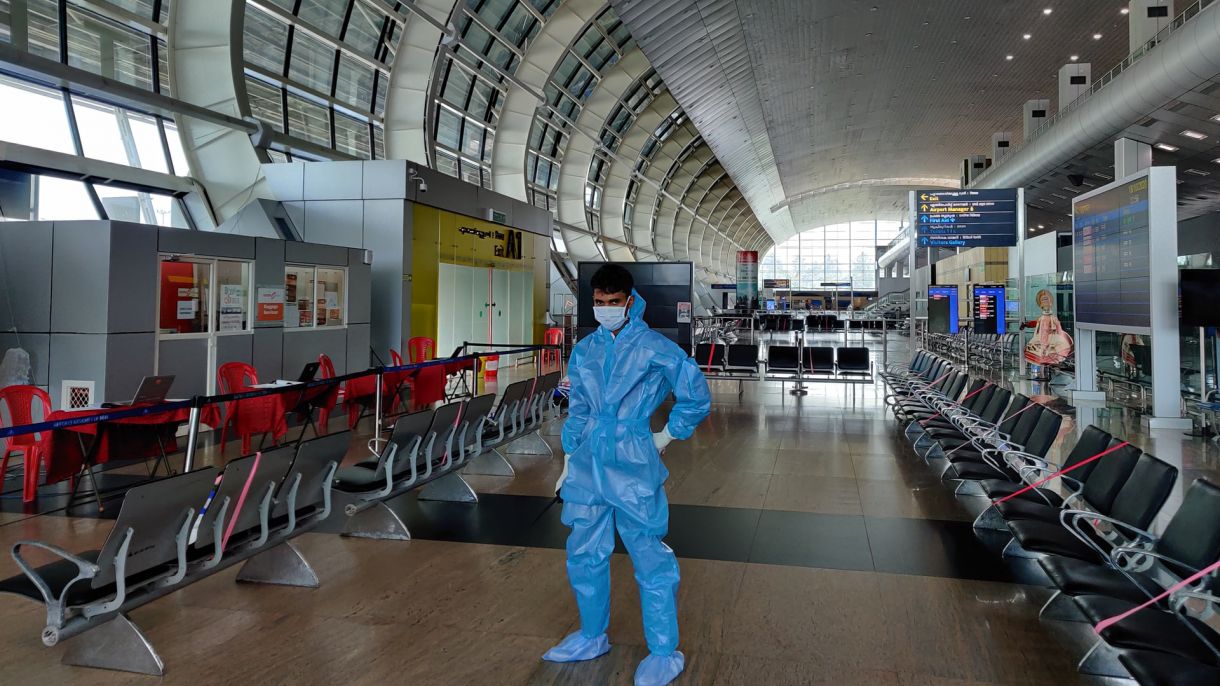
[0,0,190,227]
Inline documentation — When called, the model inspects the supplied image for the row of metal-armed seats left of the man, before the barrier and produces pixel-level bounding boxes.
[0,372,560,675]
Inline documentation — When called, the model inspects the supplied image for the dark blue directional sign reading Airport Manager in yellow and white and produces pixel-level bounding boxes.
[915,188,1017,248]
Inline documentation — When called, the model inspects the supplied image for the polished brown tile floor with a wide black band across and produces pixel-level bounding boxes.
[0,349,1215,686]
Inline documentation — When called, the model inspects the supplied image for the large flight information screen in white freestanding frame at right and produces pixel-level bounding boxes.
[1072,178,1152,328]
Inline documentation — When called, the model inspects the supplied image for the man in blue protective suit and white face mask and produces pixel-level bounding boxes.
[543,264,711,686]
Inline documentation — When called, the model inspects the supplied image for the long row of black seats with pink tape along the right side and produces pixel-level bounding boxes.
[882,353,1220,686]
